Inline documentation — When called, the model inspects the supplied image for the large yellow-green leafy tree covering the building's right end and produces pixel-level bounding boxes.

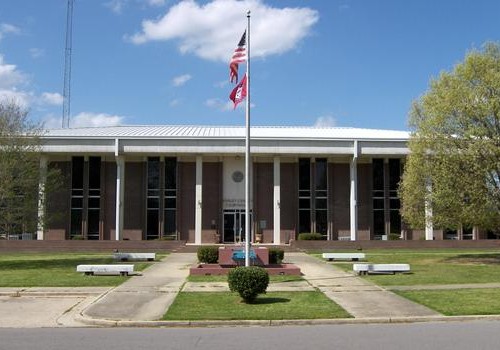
[400,43,500,228]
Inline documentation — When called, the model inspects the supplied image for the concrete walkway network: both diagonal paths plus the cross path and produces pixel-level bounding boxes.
[4,252,500,327]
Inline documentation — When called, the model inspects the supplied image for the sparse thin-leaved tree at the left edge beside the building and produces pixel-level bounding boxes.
[0,101,59,237]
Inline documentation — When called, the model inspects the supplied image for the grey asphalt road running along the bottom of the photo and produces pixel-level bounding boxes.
[0,321,500,350]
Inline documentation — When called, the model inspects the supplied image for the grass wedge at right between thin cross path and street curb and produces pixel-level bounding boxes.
[396,288,500,316]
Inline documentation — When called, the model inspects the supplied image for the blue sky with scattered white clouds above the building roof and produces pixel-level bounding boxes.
[0,0,500,130]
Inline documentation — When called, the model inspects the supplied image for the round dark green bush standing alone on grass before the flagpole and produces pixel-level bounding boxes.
[227,266,269,304]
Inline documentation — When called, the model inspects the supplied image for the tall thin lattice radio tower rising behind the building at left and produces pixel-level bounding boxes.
[62,0,74,129]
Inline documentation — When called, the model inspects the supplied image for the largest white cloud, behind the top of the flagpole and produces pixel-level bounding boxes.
[128,0,319,62]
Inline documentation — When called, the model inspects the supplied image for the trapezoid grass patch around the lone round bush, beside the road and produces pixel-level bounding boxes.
[163,291,351,320]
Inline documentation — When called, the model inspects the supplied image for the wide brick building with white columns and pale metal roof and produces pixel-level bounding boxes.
[34,125,480,244]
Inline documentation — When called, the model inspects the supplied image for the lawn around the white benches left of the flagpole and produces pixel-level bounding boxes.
[0,253,156,287]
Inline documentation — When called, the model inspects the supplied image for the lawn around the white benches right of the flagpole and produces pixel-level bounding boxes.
[315,249,500,286]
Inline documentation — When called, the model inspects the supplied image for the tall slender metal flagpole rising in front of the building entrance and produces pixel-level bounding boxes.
[245,11,251,267]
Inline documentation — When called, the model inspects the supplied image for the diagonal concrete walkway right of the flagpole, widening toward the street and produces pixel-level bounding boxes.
[285,253,442,318]
